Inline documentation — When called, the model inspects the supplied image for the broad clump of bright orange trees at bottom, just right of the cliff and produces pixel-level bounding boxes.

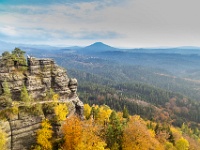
[62,116,106,150]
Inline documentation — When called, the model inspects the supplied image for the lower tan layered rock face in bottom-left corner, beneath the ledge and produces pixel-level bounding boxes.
[0,108,45,150]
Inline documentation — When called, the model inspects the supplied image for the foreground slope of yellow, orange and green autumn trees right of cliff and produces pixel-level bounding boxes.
[59,104,200,150]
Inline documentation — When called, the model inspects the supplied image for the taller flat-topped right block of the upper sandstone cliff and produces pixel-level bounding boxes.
[26,57,71,100]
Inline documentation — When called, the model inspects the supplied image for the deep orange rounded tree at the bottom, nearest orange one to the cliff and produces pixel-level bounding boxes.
[62,116,82,150]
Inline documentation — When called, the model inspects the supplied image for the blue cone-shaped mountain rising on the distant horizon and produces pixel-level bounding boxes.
[78,42,120,54]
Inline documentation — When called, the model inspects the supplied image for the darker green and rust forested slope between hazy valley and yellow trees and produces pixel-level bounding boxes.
[67,70,200,127]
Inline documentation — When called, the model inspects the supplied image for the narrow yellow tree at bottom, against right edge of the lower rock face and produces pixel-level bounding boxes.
[35,119,53,150]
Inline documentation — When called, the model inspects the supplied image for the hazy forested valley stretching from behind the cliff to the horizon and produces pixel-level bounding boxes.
[18,43,200,127]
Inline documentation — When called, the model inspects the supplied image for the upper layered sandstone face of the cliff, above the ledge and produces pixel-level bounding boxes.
[0,57,81,100]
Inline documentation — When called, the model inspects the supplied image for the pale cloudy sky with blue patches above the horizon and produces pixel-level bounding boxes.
[0,0,200,48]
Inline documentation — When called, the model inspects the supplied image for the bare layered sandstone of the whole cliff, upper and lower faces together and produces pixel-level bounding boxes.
[0,57,83,150]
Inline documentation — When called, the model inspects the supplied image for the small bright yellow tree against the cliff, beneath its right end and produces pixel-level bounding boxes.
[54,103,68,121]
